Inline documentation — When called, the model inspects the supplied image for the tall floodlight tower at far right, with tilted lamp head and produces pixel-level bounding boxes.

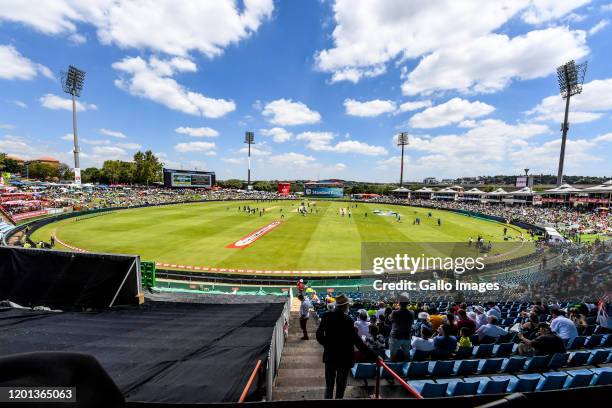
[557,60,587,187]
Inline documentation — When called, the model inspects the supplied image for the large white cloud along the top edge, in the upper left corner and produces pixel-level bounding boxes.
[0,0,274,57]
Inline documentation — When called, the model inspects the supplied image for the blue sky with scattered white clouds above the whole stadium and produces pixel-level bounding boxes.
[0,0,612,181]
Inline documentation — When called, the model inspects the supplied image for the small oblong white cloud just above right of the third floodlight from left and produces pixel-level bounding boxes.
[409,98,495,128]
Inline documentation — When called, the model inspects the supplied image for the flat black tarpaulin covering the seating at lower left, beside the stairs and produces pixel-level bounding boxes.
[0,302,284,403]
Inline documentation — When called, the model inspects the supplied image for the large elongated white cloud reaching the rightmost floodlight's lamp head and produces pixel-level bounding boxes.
[402,27,589,95]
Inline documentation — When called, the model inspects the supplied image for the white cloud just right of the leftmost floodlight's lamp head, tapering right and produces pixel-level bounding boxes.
[113,57,236,118]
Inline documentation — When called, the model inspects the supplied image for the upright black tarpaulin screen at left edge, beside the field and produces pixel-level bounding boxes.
[0,247,139,309]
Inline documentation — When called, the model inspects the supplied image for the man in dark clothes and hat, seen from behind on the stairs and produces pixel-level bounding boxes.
[317,295,378,399]
